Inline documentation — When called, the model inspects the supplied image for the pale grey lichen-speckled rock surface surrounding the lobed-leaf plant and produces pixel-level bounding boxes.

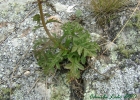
[0,0,140,100]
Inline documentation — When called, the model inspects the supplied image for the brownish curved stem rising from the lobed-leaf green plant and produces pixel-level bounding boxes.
[37,0,65,50]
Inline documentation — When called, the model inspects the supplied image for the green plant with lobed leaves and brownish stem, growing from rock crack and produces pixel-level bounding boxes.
[34,0,99,81]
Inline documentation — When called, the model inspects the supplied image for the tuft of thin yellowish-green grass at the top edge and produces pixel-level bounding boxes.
[90,0,128,28]
